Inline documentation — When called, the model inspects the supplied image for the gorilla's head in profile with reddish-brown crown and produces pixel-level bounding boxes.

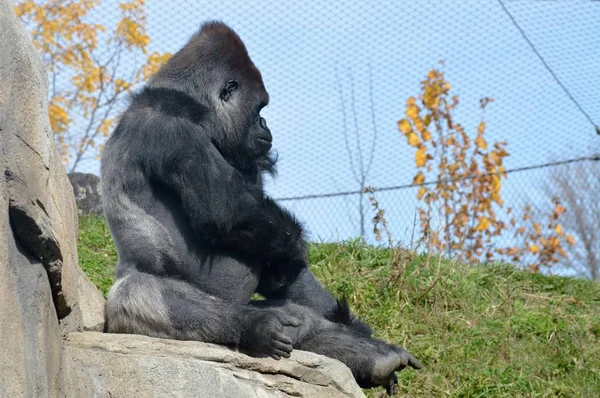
[148,22,272,166]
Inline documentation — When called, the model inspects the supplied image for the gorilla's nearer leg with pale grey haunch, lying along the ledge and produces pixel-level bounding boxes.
[106,265,300,359]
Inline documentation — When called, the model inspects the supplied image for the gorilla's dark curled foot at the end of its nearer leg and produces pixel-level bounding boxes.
[240,309,301,359]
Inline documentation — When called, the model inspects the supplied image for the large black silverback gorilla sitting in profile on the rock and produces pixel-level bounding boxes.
[101,22,421,394]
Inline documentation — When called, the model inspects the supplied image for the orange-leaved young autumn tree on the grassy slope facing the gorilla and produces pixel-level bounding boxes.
[398,63,575,271]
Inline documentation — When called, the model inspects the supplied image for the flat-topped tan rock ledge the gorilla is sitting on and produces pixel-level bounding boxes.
[62,332,364,398]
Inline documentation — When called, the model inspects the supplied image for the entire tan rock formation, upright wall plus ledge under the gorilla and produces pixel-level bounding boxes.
[0,0,363,398]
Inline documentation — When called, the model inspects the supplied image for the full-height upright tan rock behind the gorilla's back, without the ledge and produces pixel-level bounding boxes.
[0,0,104,397]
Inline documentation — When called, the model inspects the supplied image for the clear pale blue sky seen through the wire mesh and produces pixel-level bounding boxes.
[75,0,600,249]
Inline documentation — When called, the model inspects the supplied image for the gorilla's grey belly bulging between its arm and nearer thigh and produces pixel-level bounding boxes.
[192,256,261,304]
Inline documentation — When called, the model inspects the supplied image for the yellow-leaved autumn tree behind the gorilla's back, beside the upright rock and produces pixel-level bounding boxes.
[15,0,169,171]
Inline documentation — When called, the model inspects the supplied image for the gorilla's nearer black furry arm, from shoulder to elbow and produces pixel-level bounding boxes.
[149,118,307,279]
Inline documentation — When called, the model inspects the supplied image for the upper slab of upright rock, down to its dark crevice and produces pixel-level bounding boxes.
[0,0,104,338]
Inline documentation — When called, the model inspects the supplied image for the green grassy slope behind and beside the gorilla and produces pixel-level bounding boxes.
[79,218,600,398]
